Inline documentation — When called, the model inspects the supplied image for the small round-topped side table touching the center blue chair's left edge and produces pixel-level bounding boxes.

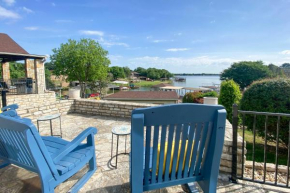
[110,125,131,169]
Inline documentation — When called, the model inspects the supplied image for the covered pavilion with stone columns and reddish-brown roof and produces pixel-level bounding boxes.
[0,33,46,94]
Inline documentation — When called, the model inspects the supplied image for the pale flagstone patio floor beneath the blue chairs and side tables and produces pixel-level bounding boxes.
[0,114,290,193]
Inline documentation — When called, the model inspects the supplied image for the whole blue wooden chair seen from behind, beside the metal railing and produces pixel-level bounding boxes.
[130,104,226,193]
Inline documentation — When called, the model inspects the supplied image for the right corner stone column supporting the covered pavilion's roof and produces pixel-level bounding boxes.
[34,59,45,94]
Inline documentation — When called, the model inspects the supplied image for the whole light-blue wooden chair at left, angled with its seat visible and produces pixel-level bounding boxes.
[0,106,97,193]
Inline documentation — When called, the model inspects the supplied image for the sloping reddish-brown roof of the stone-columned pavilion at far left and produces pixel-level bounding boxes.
[0,33,29,54]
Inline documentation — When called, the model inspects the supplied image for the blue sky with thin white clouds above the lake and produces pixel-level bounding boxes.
[0,0,290,73]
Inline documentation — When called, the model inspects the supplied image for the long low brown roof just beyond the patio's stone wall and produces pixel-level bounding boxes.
[105,91,178,100]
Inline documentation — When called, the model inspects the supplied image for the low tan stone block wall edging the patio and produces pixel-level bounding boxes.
[0,92,246,175]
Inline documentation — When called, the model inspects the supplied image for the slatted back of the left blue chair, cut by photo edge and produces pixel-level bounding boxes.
[0,114,58,176]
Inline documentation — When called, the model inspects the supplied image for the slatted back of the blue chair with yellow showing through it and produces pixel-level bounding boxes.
[131,104,225,191]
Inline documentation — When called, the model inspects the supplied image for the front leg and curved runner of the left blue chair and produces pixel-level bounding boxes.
[68,155,97,193]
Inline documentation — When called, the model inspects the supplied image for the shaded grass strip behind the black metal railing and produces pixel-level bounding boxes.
[238,129,288,165]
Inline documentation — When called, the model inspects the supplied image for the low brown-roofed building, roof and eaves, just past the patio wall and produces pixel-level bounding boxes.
[104,91,178,104]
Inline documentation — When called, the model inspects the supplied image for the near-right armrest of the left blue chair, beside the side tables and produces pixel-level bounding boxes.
[52,127,98,163]
